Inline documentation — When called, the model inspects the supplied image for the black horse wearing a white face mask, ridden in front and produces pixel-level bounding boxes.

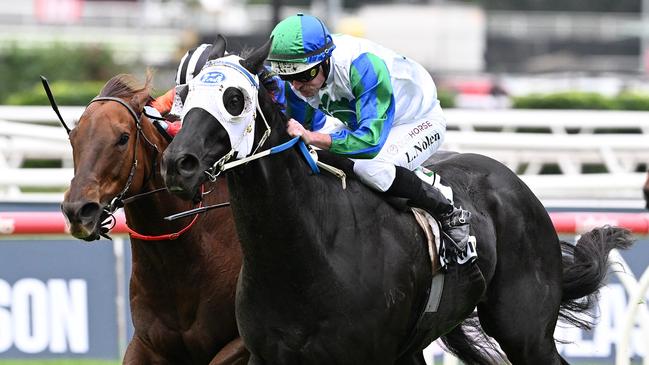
[163,38,632,365]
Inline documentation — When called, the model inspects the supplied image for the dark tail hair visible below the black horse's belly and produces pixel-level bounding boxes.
[441,312,507,365]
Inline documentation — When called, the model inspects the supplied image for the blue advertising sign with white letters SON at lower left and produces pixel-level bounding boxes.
[0,240,119,359]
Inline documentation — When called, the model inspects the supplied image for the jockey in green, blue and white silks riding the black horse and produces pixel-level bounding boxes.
[268,14,471,250]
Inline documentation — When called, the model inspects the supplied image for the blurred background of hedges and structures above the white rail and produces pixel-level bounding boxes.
[0,0,649,109]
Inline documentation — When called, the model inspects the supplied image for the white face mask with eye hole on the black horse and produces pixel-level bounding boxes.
[182,55,259,158]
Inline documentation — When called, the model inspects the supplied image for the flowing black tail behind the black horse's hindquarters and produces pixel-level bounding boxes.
[559,226,634,329]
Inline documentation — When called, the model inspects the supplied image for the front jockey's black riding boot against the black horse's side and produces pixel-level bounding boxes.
[386,166,471,250]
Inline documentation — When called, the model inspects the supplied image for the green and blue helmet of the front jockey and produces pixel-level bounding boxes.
[268,14,336,75]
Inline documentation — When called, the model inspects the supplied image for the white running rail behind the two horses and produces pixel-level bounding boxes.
[0,106,649,202]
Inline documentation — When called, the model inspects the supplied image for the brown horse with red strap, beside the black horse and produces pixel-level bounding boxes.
[61,75,249,365]
